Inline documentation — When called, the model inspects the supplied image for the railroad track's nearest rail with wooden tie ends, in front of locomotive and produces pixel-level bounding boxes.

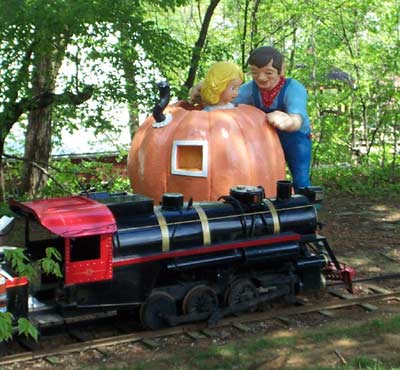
[0,276,400,366]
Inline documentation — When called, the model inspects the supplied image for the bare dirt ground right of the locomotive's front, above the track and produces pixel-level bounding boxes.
[319,195,400,277]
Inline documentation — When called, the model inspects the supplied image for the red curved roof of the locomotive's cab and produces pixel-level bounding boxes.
[9,196,117,238]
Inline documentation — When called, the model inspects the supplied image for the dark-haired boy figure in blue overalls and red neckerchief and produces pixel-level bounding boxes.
[233,46,311,192]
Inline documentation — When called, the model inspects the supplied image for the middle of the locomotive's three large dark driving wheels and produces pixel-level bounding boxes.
[182,285,218,314]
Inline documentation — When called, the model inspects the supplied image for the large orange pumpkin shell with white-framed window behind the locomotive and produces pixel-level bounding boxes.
[128,105,286,202]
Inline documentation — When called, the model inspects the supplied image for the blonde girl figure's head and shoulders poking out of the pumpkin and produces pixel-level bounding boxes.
[201,62,244,112]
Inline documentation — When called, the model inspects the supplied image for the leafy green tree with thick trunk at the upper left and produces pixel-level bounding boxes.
[0,0,191,196]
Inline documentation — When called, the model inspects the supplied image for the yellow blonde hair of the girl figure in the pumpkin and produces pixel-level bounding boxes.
[201,62,244,105]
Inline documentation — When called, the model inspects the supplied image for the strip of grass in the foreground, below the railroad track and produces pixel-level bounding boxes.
[82,314,400,370]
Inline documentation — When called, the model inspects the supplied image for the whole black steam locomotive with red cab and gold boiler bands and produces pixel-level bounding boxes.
[0,182,353,329]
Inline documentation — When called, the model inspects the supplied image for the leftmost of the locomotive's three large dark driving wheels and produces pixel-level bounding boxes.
[140,292,177,330]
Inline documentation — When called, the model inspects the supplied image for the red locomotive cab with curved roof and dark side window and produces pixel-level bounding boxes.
[10,196,116,285]
